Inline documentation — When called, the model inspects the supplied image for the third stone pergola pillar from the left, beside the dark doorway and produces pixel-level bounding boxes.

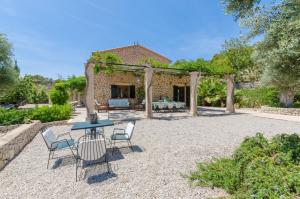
[190,72,199,117]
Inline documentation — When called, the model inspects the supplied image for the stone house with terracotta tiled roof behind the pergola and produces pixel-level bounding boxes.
[92,45,190,106]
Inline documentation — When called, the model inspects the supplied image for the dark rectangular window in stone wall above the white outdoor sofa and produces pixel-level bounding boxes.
[111,85,135,98]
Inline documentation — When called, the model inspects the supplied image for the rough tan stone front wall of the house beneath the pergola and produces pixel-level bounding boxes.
[94,72,190,104]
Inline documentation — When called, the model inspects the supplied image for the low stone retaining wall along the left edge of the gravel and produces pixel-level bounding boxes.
[0,121,44,170]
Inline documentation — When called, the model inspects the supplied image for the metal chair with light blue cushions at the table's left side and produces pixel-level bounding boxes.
[41,128,75,169]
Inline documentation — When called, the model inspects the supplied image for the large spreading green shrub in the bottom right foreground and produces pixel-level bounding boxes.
[189,133,300,199]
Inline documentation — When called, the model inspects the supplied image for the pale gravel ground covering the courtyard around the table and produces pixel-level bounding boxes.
[0,111,300,198]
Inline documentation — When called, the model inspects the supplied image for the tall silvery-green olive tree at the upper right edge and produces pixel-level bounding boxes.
[224,0,300,107]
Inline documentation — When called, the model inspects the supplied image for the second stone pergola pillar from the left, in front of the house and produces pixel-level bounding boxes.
[145,67,153,118]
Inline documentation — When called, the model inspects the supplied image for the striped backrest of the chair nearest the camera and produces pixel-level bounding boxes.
[77,135,106,161]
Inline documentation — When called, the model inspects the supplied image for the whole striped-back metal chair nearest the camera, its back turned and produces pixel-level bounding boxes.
[76,134,110,182]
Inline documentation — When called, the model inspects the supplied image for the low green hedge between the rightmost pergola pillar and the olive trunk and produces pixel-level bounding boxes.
[235,87,280,108]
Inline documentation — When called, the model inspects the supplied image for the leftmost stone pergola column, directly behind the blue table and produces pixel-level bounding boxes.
[85,63,95,119]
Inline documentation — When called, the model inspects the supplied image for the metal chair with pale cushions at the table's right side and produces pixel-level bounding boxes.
[111,121,135,152]
